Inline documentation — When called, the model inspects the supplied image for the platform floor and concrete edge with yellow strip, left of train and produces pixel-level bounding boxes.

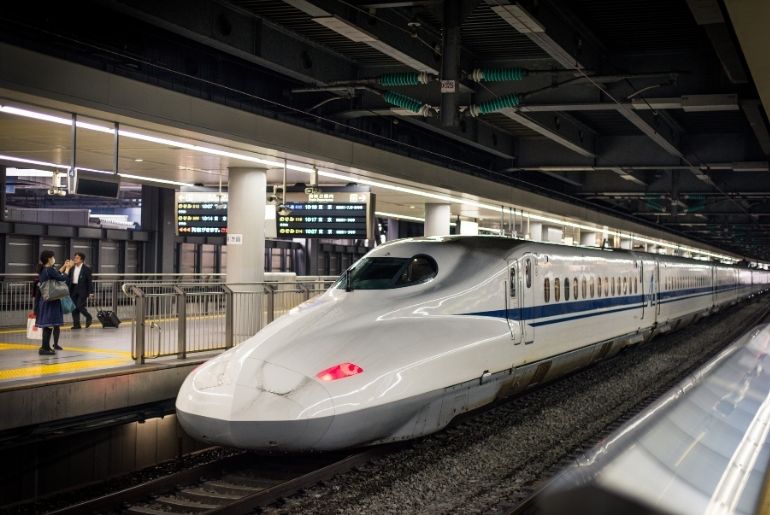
[0,320,216,442]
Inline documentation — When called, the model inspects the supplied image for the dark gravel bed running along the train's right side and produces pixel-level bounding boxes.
[264,297,770,513]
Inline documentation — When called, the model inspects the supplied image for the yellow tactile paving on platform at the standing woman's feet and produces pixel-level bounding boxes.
[0,342,133,380]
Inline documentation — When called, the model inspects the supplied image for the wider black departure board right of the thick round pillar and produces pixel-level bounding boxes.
[276,193,371,239]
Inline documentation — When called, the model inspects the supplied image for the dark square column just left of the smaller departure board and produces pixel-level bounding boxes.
[142,185,176,274]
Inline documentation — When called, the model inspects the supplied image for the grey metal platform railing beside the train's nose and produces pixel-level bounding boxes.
[123,277,336,363]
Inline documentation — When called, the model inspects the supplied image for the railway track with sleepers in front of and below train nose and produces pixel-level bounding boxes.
[50,448,382,515]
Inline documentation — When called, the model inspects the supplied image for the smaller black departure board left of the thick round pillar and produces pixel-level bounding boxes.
[176,191,227,236]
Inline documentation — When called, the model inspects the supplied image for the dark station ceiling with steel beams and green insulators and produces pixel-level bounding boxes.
[0,0,770,260]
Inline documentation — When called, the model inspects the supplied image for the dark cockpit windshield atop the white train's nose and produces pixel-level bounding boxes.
[335,254,438,291]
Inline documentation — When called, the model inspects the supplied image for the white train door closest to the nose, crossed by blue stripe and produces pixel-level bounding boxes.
[508,254,537,344]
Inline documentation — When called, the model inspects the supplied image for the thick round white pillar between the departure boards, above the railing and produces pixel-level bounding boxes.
[227,167,267,283]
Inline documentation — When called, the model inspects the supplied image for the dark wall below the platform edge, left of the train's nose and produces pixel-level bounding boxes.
[0,415,208,511]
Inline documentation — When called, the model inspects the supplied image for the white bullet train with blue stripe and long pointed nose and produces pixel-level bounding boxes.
[176,236,770,451]
